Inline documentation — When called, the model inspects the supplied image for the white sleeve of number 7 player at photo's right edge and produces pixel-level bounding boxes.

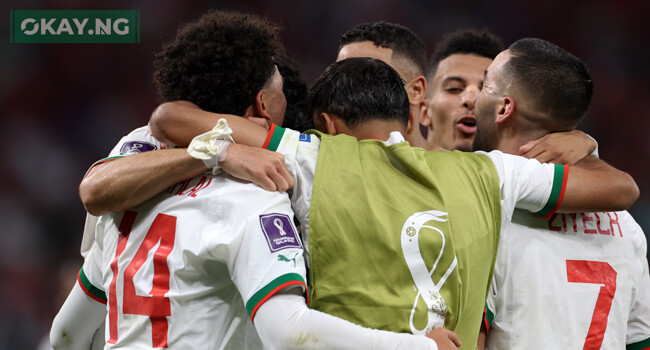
[621,213,650,349]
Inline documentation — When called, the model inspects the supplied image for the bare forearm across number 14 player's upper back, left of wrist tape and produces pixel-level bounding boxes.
[79,148,206,216]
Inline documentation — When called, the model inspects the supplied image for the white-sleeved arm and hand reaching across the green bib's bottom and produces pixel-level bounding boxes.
[254,292,460,350]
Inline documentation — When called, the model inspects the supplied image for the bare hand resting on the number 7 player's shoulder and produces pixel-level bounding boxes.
[519,130,596,165]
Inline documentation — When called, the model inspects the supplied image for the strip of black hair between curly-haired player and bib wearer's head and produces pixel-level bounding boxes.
[275,53,314,131]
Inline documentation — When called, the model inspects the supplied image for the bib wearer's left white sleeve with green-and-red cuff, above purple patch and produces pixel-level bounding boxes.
[263,124,320,251]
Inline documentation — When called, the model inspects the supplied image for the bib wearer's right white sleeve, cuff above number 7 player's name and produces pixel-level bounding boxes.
[477,151,569,220]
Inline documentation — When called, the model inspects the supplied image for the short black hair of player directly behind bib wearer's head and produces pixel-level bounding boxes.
[339,21,427,75]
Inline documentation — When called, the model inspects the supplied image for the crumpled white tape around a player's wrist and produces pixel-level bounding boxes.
[187,118,235,175]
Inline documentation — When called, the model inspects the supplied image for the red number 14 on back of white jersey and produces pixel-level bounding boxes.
[108,211,176,348]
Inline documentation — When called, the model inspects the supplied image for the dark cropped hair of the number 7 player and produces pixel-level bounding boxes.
[504,38,594,131]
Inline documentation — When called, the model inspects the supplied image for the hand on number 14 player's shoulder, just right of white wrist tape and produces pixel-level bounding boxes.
[219,144,293,192]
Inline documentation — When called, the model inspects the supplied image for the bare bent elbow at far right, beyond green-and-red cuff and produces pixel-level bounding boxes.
[558,156,639,212]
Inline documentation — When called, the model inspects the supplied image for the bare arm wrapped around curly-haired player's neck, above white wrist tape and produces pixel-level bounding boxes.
[149,101,268,147]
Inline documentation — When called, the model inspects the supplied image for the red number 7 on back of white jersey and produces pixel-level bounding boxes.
[566,260,616,350]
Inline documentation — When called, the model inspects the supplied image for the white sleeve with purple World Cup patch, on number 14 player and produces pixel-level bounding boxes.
[228,192,308,319]
